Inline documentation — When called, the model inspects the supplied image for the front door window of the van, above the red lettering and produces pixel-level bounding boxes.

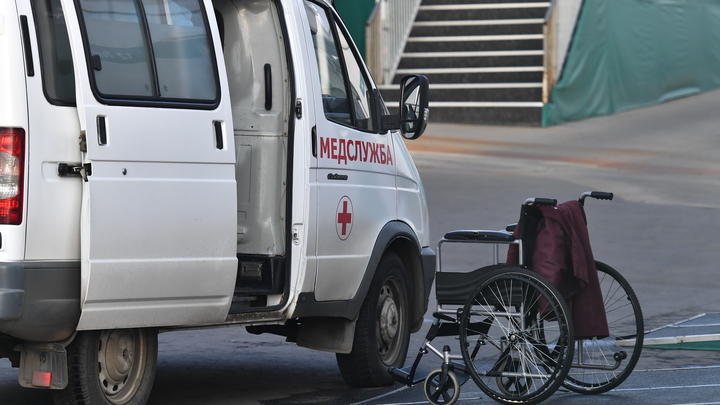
[305,1,373,131]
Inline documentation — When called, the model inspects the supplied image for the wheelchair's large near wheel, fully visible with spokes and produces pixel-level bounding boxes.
[460,266,574,404]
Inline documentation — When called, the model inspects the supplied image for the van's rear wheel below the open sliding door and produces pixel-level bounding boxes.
[53,329,157,405]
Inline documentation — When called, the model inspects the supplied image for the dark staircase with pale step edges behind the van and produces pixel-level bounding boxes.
[381,0,550,125]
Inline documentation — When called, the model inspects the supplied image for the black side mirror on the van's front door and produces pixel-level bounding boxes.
[399,75,430,139]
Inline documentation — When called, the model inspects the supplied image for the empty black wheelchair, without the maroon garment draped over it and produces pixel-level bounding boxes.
[389,191,643,405]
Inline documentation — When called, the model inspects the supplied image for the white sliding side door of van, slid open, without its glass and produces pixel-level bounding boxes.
[62,0,237,330]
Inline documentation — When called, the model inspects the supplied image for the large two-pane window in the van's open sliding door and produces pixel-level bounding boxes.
[80,0,218,102]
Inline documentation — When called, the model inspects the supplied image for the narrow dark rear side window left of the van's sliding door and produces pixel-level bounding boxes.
[32,0,75,106]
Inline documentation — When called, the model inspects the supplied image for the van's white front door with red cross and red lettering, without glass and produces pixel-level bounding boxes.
[305,0,397,302]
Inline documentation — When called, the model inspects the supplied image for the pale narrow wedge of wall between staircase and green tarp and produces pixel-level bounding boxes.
[542,0,584,103]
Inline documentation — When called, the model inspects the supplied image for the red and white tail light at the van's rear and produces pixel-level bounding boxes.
[0,128,25,225]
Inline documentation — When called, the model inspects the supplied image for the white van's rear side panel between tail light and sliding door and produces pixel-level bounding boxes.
[17,2,82,261]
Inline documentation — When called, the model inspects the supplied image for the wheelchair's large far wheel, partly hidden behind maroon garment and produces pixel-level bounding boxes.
[563,261,644,394]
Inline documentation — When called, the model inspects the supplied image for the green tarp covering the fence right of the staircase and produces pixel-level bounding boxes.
[542,0,720,126]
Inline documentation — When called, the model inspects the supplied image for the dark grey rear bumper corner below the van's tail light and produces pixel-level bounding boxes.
[0,262,80,342]
